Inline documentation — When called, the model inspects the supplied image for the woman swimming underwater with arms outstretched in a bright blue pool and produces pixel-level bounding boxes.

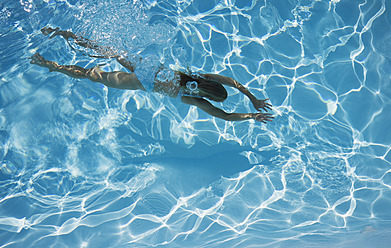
[30,27,273,123]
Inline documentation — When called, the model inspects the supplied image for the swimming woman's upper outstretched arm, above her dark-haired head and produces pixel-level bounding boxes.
[201,74,272,111]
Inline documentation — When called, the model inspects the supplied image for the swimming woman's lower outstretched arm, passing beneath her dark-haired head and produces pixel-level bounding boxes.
[181,96,273,123]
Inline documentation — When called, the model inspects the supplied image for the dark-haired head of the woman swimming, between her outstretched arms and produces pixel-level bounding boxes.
[180,72,228,102]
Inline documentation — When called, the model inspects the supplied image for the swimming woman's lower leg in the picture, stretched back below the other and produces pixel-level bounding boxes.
[30,53,145,91]
